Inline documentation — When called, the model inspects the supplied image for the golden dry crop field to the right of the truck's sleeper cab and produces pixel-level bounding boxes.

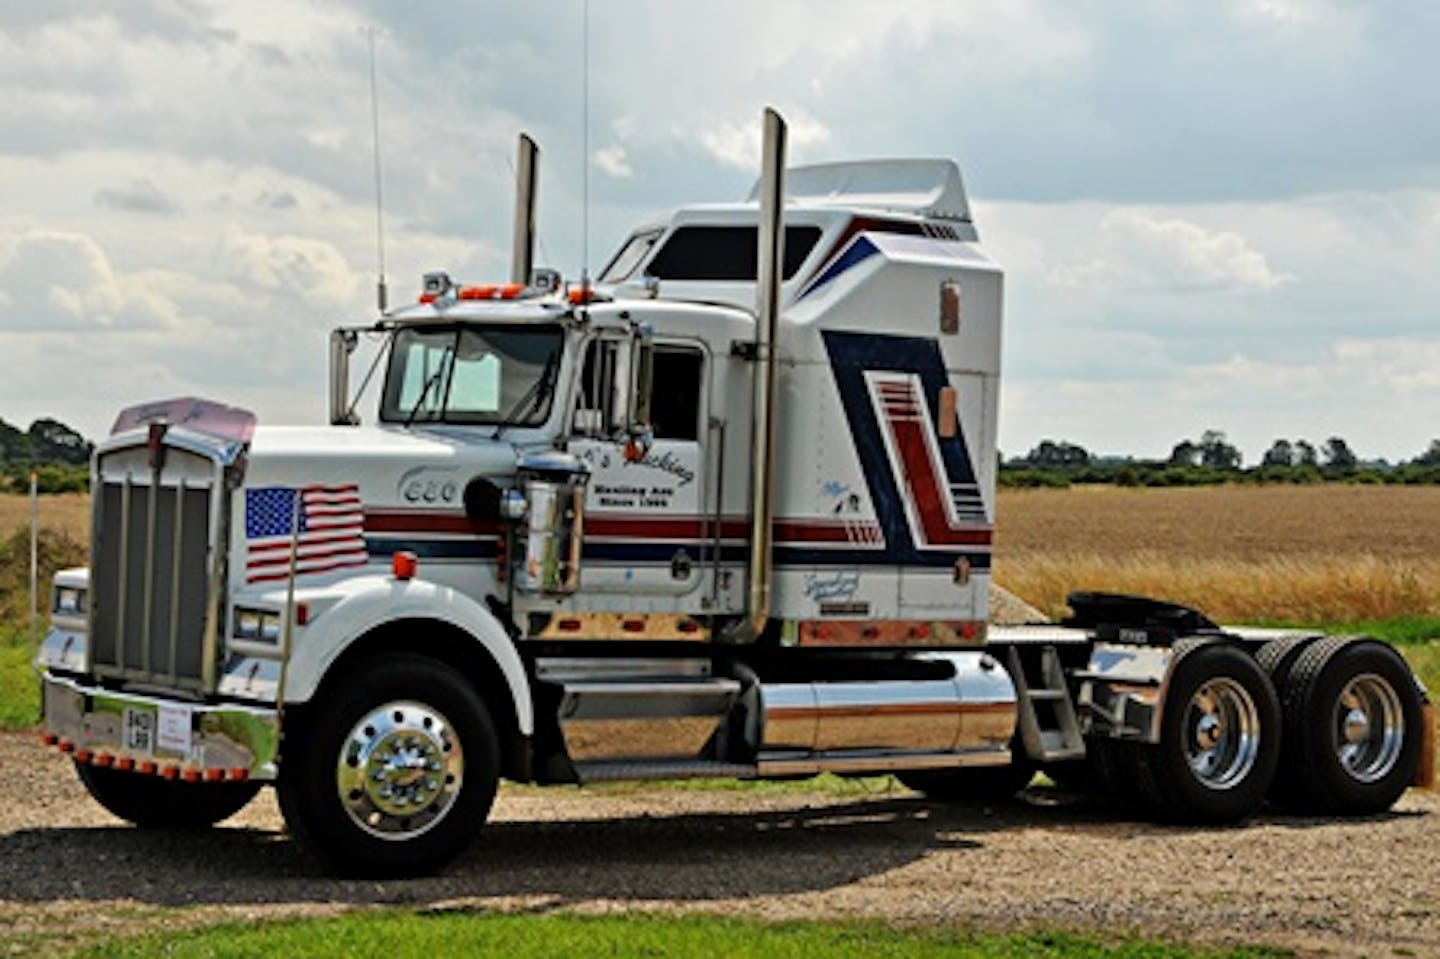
[995,485,1440,623]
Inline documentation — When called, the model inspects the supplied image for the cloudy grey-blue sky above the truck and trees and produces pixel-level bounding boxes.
[0,0,1440,461]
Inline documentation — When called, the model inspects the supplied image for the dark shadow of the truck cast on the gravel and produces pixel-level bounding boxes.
[0,795,1416,907]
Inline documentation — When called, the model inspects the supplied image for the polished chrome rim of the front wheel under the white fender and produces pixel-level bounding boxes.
[336,701,465,839]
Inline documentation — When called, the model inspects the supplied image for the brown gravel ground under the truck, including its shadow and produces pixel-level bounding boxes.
[0,734,1440,956]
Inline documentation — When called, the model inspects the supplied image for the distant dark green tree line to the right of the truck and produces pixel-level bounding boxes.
[999,429,1440,487]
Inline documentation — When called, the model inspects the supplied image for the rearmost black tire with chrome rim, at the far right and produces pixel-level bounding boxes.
[1280,636,1424,815]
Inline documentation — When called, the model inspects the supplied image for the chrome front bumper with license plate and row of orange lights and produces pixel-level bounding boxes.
[40,671,279,782]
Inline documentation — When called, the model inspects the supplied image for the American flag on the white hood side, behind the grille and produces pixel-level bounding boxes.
[245,484,367,583]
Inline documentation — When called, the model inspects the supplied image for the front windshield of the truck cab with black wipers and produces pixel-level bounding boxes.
[380,324,564,426]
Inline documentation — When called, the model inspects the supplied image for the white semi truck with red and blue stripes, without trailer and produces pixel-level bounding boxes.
[39,114,1431,874]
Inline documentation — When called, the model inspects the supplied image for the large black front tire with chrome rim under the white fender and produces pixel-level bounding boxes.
[276,655,500,877]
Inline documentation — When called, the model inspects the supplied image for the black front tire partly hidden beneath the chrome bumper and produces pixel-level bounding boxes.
[75,763,261,829]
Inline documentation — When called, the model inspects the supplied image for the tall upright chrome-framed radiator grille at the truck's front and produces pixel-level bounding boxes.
[91,448,223,690]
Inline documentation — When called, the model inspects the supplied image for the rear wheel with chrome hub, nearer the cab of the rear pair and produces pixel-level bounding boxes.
[1128,644,1280,824]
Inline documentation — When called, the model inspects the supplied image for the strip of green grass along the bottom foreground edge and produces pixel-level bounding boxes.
[73,910,1292,959]
